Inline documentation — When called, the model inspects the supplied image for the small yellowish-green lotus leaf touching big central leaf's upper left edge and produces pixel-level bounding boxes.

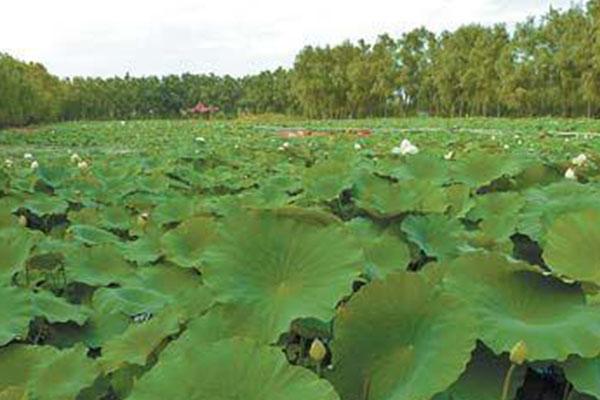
[161,217,216,268]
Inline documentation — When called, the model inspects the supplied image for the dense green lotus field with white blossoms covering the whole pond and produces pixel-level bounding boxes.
[0,118,600,400]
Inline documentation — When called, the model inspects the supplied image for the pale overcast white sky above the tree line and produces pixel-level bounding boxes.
[0,0,579,77]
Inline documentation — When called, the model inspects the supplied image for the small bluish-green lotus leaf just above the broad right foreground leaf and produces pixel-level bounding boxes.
[402,214,468,261]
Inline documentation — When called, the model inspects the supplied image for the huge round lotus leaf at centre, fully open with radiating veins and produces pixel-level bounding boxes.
[203,211,363,341]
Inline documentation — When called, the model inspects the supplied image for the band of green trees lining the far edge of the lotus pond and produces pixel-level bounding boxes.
[0,0,600,126]
